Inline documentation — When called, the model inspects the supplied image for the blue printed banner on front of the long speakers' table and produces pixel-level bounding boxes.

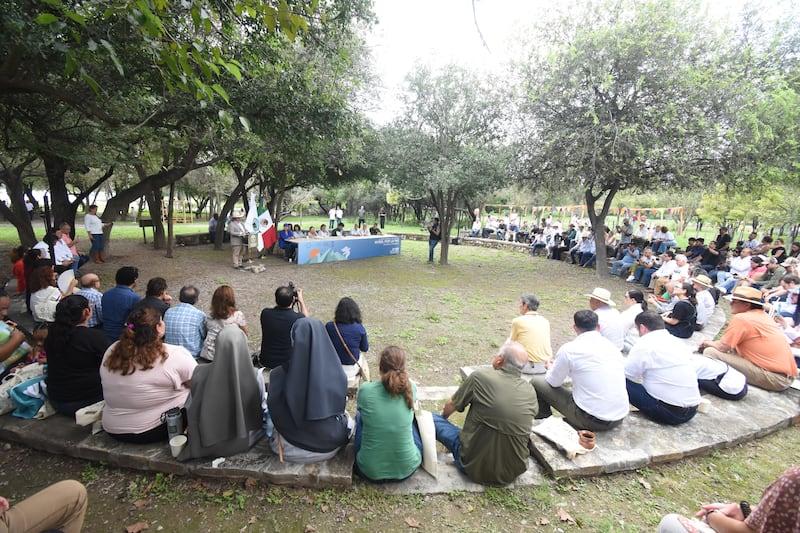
[290,235,400,265]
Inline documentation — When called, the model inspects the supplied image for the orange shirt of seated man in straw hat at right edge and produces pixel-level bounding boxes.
[720,309,797,376]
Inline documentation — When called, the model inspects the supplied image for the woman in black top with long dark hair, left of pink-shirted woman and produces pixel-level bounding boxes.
[44,295,110,416]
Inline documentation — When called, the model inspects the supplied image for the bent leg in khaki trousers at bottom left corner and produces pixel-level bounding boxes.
[0,479,89,533]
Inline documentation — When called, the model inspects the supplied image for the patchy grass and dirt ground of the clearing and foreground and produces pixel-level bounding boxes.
[0,240,800,533]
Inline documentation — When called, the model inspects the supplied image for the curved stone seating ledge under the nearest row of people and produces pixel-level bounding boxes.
[0,294,800,493]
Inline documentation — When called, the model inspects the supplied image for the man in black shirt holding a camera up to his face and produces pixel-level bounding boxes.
[259,281,309,369]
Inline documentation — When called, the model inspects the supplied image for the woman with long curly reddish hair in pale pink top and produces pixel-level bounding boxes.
[100,307,197,444]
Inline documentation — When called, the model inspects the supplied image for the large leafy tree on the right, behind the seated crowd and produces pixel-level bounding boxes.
[519,1,720,276]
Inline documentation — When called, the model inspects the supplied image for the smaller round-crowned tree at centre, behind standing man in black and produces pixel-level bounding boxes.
[383,65,507,265]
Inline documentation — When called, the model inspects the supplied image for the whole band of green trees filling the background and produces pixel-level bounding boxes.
[0,0,800,264]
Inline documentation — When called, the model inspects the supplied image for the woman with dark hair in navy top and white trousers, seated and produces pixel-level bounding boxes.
[325,296,369,378]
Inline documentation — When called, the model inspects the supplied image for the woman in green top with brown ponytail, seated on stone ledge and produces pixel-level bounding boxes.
[353,346,422,481]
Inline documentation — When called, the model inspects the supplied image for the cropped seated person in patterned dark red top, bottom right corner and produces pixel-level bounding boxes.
[658,467,800,533]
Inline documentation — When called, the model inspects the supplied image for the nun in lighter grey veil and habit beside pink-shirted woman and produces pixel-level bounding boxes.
[178,324,266,461]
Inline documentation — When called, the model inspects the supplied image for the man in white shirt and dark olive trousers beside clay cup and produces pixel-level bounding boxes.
[531,310,628,431]
